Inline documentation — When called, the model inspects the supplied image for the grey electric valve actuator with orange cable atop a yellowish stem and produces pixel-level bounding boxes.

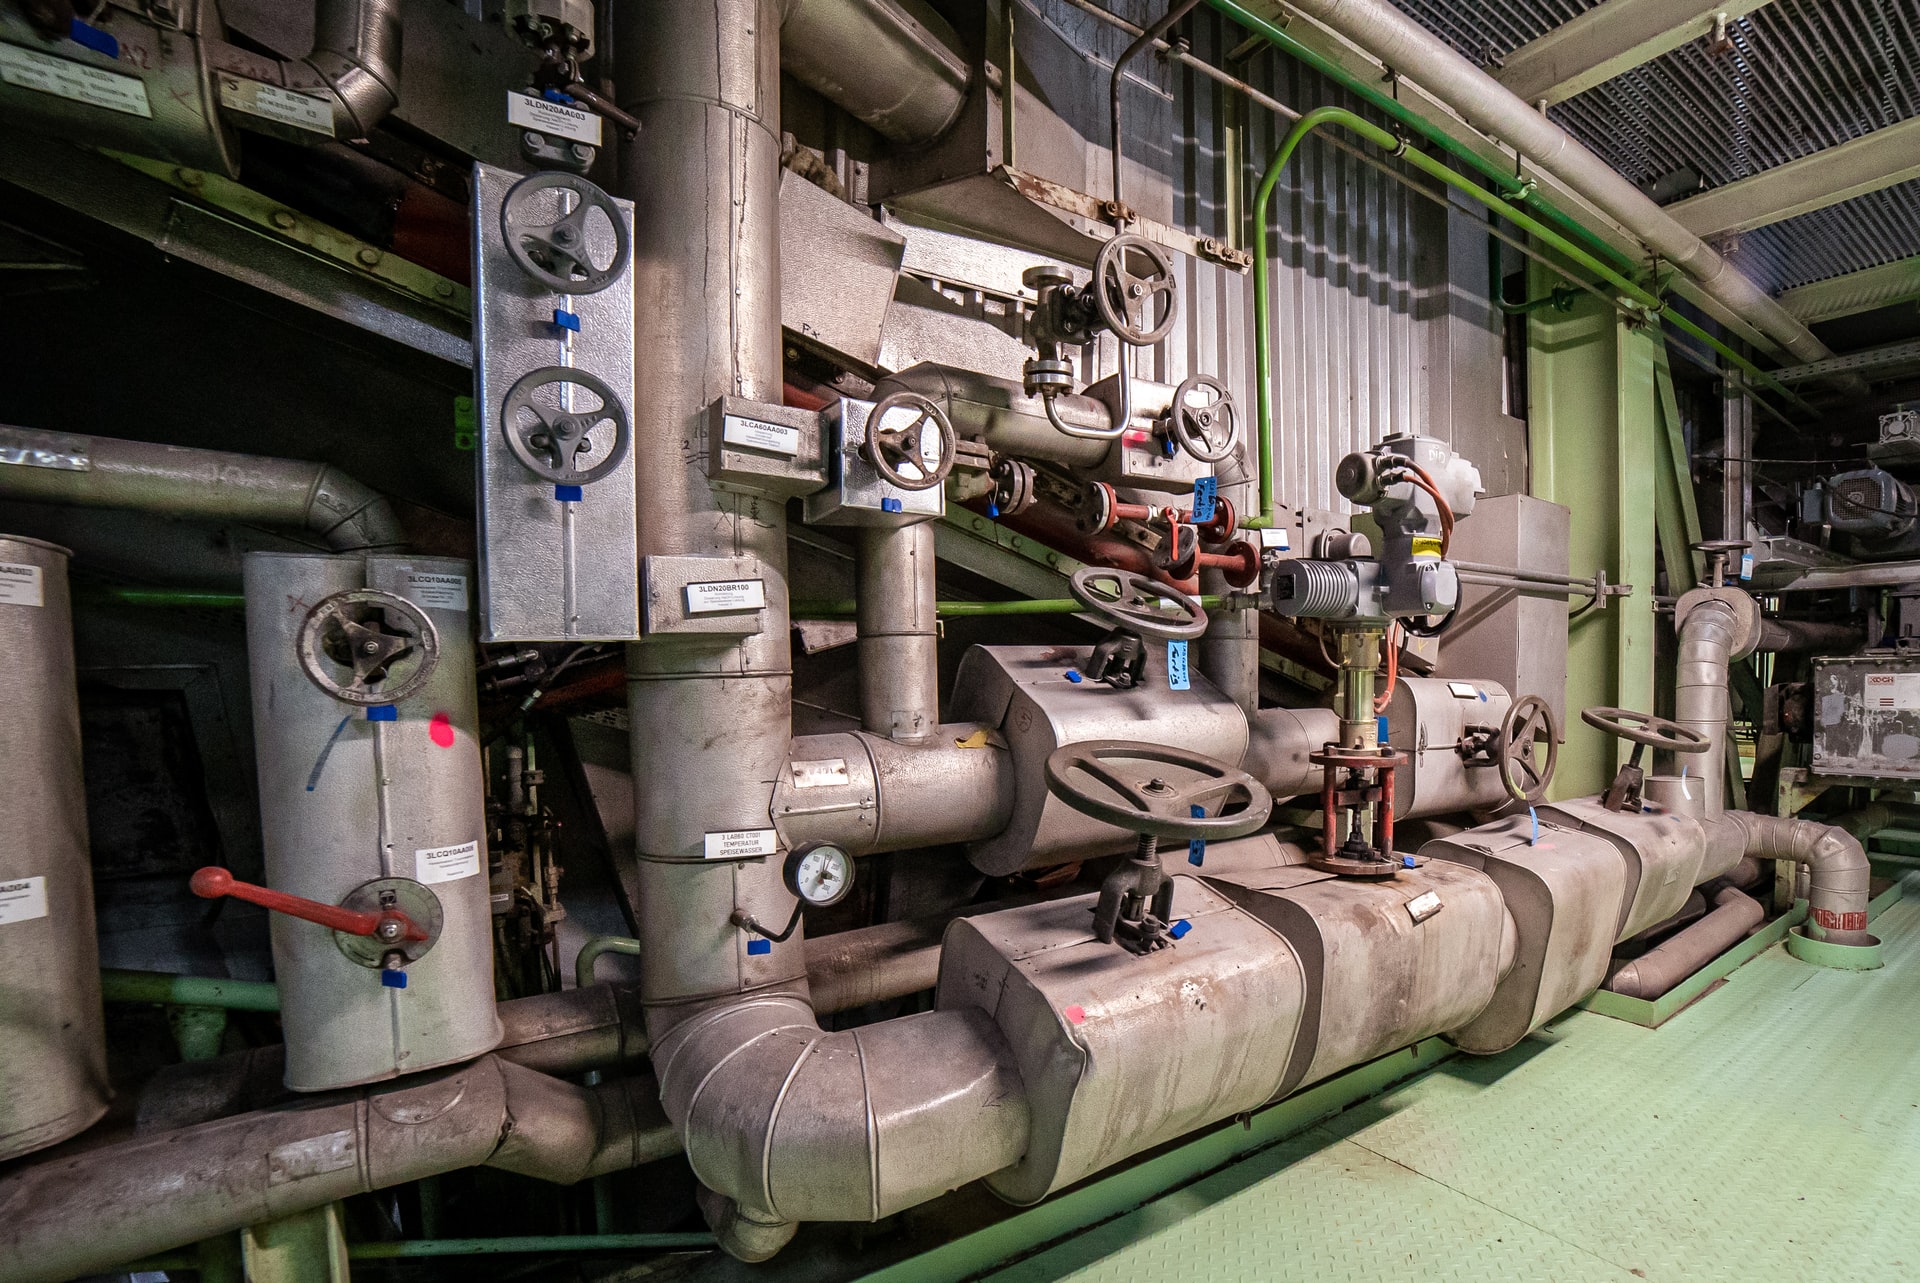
[1263,434,1482,622]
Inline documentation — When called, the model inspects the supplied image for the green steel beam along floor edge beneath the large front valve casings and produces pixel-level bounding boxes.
[866,1037,1453,1283]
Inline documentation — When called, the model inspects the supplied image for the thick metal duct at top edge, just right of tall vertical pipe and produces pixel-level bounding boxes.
[780,0,973,146]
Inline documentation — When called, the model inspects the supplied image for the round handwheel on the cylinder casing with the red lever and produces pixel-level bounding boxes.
[296,588,440,707]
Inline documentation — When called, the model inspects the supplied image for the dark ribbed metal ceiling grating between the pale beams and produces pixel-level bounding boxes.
[1394,0,1920,290]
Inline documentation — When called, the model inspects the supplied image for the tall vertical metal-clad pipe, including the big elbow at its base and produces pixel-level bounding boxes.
[614,0,1027,1260]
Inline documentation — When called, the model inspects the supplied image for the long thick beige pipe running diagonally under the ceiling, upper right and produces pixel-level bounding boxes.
[1259,0,1834,361]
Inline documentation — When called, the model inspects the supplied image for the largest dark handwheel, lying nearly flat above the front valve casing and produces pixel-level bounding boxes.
[1046,739,1273,841]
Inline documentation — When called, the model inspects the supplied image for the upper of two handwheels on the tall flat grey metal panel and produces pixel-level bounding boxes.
[499,171,634,294]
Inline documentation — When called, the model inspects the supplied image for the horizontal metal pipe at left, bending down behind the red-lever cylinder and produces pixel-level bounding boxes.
[0,428,407,553]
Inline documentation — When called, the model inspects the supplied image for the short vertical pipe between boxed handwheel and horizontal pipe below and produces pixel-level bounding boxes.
[854,522,941,743]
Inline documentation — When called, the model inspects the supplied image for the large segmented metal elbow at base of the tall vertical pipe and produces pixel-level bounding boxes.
[653,993,1029,1260]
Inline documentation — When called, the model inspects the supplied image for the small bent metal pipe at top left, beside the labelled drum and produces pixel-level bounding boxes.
[207,0,401,138]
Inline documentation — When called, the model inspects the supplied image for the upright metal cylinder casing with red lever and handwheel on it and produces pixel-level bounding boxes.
[236,553,501,1091]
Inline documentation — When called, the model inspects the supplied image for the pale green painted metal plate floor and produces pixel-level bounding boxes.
[993,874,1920,1283]
